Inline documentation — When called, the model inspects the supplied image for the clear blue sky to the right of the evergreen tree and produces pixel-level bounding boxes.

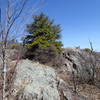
[42,0,100,50]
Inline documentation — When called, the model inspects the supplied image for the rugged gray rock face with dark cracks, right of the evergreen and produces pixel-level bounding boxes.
[63,48,100,80]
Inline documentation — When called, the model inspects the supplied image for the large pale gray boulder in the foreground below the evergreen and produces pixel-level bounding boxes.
[12,60,60,100]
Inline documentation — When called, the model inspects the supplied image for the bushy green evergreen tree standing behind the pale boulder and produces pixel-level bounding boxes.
[24,13,62,63]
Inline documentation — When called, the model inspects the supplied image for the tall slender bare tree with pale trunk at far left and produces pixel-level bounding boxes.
[0,0,44,100]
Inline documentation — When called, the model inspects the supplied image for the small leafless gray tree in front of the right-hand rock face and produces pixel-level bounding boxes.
[79,42,100,85]
